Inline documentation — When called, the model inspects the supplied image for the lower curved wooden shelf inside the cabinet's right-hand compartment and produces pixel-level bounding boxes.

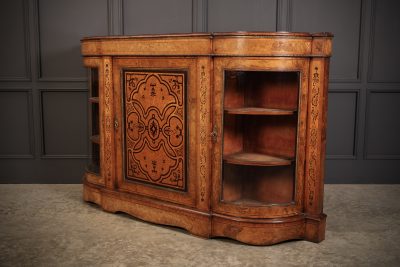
[224,152,293,166]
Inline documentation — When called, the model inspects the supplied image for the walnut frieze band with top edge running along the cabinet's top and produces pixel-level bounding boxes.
[81,32,333,57]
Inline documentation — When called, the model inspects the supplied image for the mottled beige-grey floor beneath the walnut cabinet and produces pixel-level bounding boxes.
[0,185,400,267]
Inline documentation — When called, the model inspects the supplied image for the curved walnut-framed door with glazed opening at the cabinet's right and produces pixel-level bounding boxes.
[212,57,309,218]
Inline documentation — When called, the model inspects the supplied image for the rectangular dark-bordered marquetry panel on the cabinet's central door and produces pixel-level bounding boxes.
[124,71,186,190]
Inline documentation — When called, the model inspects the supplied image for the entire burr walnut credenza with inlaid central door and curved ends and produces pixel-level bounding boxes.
[81,32,332,245]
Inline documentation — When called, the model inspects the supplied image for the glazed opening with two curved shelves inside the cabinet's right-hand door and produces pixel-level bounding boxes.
[221,71,300,206]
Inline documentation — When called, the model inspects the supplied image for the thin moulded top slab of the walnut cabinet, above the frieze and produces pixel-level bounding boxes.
[81,31,333,42]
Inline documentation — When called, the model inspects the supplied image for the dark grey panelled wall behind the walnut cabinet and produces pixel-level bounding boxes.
[0,0,400,183]
